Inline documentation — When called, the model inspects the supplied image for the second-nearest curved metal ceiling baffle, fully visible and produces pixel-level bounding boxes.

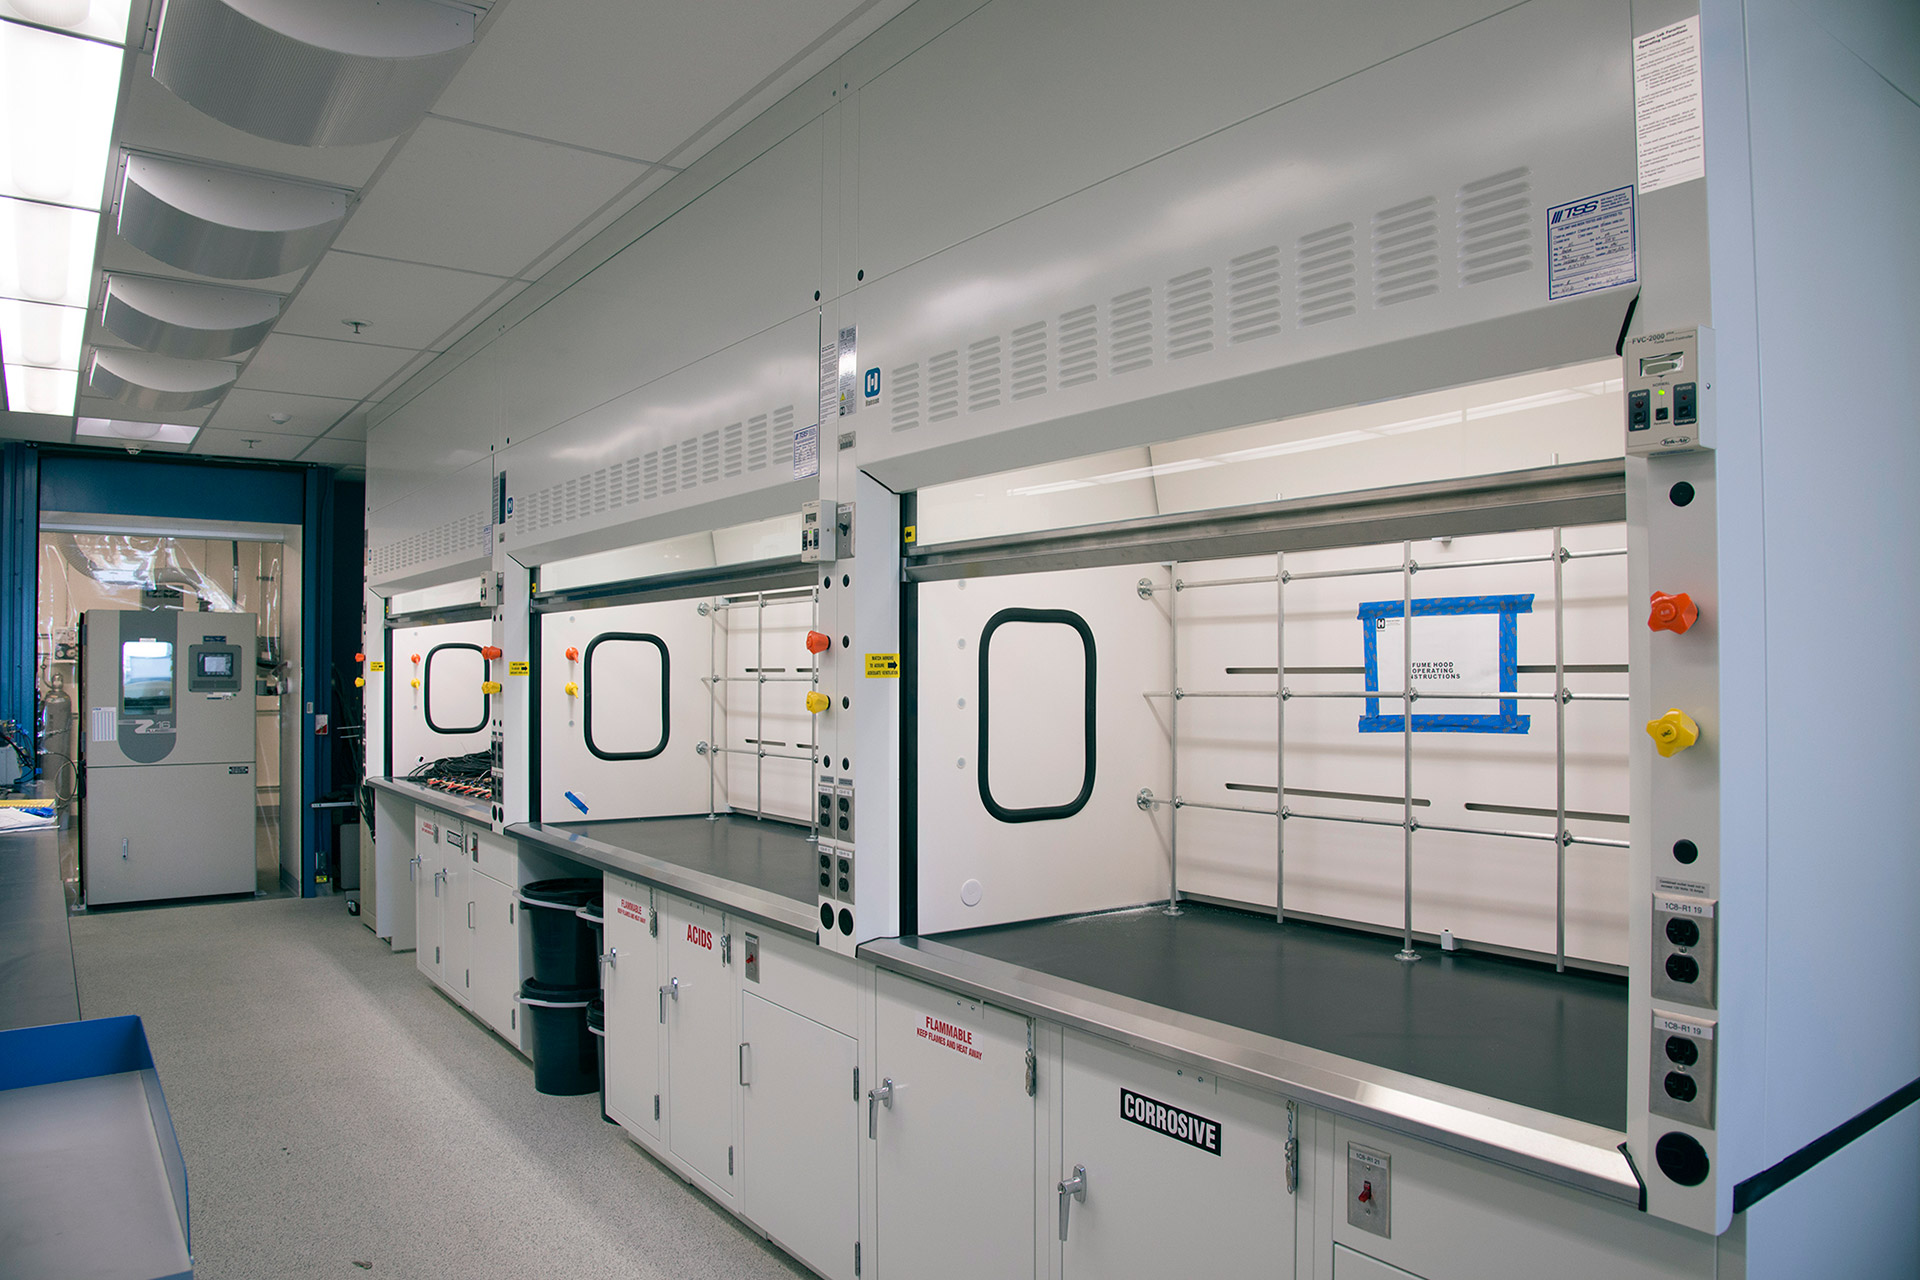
[115,154,348,280]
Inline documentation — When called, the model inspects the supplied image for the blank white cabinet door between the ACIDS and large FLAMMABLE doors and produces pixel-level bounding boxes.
[739,992,862,1280]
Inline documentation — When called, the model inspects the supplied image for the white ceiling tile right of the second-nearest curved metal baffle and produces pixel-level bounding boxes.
[334,116,643,276]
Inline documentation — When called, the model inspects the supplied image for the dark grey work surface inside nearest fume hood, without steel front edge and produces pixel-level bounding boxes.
[939,902,1626,1128]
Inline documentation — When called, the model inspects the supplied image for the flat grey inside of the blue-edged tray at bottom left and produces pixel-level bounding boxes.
[0,1071,192,1280]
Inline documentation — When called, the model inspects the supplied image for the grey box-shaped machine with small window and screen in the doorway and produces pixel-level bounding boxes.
[81,608,257,906]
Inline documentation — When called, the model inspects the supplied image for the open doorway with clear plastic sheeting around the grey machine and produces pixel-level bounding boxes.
[35,512,301,906]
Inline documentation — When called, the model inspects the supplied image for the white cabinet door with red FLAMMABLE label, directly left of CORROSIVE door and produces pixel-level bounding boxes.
[879,973,1035,1280]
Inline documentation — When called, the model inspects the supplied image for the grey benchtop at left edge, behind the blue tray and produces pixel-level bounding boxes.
[0,829,81,1031]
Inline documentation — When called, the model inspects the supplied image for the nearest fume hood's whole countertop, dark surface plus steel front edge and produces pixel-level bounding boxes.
[858,902,1640,1203]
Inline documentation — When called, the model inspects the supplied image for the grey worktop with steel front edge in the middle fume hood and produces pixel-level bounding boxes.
[509,814,820,938]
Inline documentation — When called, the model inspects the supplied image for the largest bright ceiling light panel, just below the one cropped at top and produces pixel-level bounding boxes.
[0,23,123,208]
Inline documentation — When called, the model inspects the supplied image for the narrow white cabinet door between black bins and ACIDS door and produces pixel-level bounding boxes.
[601,875,666,1140]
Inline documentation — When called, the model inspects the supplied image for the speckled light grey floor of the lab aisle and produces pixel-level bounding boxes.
[71,898,810,1280]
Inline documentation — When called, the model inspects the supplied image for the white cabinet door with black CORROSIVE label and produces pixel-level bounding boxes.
[1046,1031,1294,1280]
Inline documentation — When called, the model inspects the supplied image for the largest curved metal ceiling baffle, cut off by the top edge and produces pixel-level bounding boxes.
[154,0,474,146]
